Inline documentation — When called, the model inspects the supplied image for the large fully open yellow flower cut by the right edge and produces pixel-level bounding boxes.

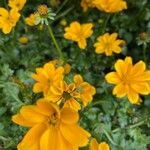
[105,57,150,104]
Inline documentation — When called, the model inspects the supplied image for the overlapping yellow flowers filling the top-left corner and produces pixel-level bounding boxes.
[0,0,26,34]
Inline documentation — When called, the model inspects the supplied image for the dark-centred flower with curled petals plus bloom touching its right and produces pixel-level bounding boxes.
[46,75,96,111]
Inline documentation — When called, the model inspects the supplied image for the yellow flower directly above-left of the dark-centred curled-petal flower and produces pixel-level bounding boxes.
[32,63,64,95]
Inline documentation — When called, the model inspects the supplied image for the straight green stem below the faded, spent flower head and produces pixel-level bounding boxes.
[48,25,64,61]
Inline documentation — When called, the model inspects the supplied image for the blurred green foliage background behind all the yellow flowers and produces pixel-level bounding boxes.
[0,0,150,150]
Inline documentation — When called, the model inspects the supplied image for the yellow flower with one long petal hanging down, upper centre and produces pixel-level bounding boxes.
[64,21,93,49]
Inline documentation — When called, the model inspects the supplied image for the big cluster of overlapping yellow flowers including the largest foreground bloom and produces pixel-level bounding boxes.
[12,60,96,150]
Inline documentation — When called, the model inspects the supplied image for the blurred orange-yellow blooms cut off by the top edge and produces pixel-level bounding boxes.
[81,0,127,13]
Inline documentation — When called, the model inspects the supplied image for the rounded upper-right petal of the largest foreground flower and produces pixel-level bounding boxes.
[61,108,79,124]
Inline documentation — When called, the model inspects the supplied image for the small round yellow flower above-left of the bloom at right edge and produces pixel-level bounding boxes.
[94,33,125,56]
